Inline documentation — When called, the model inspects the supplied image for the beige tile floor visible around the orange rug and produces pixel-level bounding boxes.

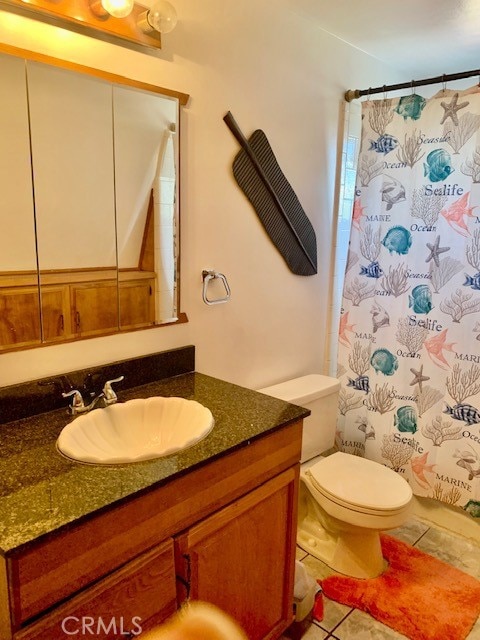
[285,520,480,640]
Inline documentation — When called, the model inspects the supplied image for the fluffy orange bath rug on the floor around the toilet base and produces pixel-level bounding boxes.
[321,535,480,640]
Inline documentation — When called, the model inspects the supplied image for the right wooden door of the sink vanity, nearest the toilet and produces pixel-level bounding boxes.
[175,468,298,640]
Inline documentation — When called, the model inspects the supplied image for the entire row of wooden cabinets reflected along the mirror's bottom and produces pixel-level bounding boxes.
[0,269,155,351]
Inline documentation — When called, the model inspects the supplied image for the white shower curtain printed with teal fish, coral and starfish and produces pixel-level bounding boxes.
[337,88,480,522]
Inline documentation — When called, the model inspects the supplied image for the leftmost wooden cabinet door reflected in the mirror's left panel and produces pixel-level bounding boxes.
[0,287,40,348]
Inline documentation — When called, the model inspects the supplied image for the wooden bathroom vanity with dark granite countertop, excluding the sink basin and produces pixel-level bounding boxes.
[0,348,308,640]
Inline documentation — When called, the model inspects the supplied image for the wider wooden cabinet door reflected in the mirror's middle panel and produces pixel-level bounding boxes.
[71,279,118,336]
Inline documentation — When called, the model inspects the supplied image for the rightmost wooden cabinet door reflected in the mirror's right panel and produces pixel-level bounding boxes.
[119,279,155,329]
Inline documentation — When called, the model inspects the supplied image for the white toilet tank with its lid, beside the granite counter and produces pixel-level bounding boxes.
[258,373,340,462]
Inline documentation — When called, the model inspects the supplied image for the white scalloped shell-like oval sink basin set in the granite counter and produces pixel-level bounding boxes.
[57,396,214,464]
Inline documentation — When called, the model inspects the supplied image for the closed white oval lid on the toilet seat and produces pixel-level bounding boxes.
[309,451,412,511]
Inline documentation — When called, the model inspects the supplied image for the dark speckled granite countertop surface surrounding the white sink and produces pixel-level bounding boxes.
[0,373,309,554]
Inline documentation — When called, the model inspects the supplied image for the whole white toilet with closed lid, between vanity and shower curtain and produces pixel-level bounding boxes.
[259,374,412,578]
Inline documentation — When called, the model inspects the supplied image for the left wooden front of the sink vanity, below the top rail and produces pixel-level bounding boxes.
[13,538,176,640]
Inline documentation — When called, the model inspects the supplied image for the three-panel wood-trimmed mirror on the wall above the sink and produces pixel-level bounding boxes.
[0,47,188,350]
